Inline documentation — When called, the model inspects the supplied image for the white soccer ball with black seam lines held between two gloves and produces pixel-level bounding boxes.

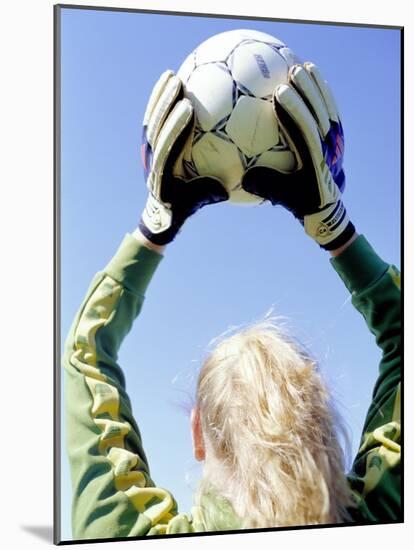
[176,30,300,205]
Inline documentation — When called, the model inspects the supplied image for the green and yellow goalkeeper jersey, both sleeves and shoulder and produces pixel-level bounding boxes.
[63,234,402,539]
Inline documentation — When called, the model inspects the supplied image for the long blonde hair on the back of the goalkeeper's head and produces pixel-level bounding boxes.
[196,319,353,528]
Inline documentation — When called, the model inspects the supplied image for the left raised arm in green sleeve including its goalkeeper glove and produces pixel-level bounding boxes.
[62,71,228,539]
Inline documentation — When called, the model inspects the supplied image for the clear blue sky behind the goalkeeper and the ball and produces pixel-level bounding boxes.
[61,9,400,540]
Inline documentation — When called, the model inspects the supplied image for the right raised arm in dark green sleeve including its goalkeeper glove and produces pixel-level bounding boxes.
[242,63,402,521]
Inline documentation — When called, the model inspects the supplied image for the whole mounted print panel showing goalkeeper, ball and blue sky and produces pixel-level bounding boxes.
[55,6,403,544]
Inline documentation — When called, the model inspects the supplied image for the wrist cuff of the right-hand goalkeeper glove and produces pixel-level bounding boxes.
[304,201,355,250]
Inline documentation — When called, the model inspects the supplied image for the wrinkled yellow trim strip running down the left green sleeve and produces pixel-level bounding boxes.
[70,275,175,533]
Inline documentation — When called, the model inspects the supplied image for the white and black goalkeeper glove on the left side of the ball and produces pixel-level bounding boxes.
[139,71,228,245]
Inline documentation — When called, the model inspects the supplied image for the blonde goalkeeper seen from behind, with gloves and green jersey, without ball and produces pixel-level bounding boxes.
[63,63,402,539]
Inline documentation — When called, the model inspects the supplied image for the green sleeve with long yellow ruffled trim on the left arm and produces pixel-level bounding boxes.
[63,234,191,539]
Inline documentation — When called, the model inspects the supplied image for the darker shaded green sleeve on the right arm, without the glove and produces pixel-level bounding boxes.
[331,235,402,522]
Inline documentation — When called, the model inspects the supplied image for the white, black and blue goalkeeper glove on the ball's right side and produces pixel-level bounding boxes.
[242,63,355,250]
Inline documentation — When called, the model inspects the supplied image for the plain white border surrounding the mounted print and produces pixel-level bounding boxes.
[0,0,414,550]
